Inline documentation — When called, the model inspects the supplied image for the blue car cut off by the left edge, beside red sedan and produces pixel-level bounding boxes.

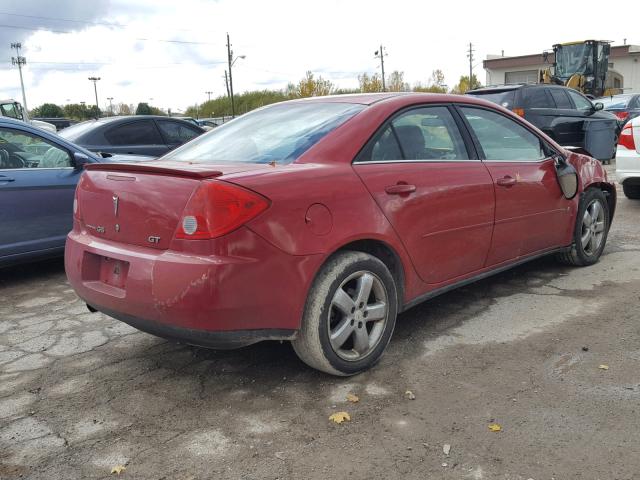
[0,118,151,266]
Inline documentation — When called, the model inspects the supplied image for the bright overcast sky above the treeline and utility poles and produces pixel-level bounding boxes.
[0,0,640,111]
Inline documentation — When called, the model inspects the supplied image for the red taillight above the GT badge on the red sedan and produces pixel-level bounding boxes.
[175,180,269,240]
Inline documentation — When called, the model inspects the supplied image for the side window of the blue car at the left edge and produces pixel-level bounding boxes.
[0,128,72,169]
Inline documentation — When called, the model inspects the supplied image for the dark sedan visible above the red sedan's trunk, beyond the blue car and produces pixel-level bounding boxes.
[59,115,204,157]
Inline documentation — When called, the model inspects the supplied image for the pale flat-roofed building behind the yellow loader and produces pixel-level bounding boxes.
[483,45,640,93]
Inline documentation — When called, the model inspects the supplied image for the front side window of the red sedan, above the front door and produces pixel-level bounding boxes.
[461,107,546,162]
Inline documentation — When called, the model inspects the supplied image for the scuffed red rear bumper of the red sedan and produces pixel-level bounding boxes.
[65,228,321,348]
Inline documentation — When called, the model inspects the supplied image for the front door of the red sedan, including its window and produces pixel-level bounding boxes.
[460,106,573,266]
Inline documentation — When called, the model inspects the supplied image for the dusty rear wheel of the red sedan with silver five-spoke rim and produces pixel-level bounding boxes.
[292,251,398,376]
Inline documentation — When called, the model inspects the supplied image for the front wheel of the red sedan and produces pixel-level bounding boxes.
[558,188,610,267]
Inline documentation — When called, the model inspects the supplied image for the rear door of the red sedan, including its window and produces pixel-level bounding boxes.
[354,106,494,285]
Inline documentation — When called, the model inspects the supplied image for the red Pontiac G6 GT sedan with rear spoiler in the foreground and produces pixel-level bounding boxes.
[65,93,616,375]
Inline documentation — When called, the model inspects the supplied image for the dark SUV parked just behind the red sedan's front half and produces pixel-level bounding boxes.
[467,84,619,163]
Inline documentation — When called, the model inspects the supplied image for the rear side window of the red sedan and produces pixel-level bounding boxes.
[357,107,469,162]
